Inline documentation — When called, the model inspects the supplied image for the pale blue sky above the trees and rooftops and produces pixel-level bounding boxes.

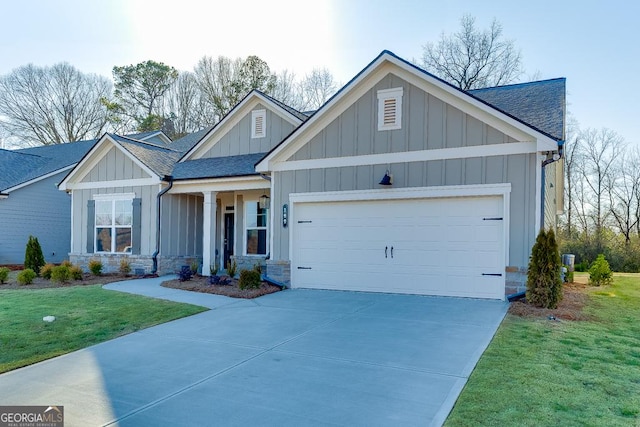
[0,0,640,145]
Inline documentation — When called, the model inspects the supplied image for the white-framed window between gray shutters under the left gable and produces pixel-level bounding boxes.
[94,194,135,253]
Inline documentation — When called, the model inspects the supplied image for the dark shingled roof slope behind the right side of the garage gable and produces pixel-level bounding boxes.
[467,78,566,141]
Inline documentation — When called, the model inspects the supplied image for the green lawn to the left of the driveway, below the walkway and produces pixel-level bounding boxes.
[0,285,207,373]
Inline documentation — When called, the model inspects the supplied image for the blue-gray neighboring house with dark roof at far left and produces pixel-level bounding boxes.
[0,131,171,265]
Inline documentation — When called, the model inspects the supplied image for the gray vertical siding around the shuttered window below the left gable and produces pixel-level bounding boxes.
[71,185,160,255]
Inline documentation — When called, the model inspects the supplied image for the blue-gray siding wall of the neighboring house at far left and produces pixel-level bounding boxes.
[0,172,71,265]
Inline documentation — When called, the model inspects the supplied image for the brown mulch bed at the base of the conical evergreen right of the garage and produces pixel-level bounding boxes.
[509,282,591,320]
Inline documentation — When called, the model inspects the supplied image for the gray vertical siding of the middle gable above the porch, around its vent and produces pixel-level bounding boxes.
[202,104,294,158]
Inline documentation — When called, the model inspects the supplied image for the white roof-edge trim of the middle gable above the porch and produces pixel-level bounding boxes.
[179,89,308,162]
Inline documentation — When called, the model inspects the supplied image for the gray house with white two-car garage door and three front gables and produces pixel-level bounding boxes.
[60,51,565,299]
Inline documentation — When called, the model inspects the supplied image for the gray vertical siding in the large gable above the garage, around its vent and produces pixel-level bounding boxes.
[291,74,513,161]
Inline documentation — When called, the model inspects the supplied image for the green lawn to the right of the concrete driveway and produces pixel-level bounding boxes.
[445,274,640,427]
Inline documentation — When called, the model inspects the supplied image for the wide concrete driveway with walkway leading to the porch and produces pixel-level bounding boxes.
[0,279,508,426]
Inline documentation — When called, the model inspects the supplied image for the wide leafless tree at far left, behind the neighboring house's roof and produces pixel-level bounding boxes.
[0,63,112,146]
